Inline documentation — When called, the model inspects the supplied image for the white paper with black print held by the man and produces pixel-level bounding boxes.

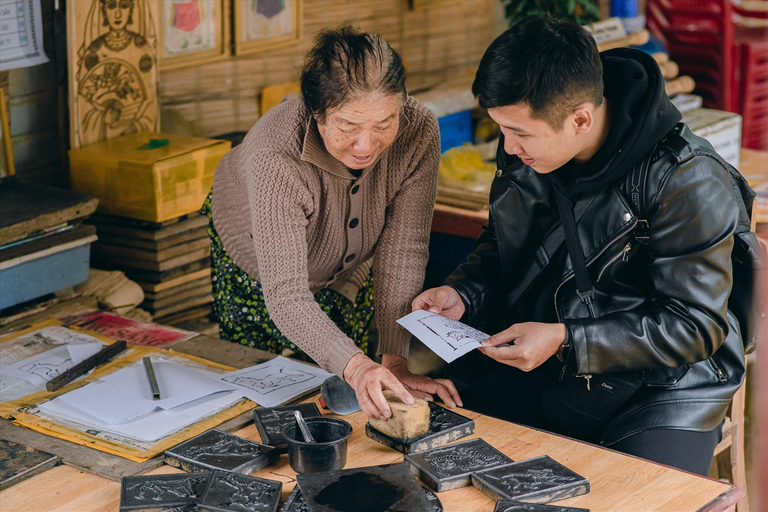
[397,311,490,363]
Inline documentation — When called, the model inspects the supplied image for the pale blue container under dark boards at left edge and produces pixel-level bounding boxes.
[0,236,96,309]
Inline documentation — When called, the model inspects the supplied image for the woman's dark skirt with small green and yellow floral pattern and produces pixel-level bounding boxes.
[200,194,373,354]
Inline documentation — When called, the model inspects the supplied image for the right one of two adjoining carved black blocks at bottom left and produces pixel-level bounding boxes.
[199,471,283,512]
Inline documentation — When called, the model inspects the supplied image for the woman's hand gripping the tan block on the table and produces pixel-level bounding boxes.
[344,352,413,420]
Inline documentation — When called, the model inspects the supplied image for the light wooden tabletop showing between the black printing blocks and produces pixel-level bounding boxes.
[0,392,743,512]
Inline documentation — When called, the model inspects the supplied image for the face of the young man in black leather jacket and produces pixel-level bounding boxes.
[488,103,582,174]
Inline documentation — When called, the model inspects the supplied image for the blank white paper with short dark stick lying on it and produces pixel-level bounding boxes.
[59,358,235,424]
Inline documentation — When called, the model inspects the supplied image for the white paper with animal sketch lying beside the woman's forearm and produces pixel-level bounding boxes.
[220,356,333,407]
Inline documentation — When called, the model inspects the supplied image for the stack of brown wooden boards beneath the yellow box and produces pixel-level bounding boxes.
[89,213,213,325]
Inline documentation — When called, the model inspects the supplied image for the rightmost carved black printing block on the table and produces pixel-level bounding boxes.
[472,455,589,503]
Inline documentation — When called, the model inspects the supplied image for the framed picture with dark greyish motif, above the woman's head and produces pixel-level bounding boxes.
[235,0,302,55]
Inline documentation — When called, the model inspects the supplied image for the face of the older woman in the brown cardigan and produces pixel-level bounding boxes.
[317,93,400,170]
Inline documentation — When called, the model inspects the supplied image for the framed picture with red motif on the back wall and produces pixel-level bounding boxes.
[160,0,230,70]
